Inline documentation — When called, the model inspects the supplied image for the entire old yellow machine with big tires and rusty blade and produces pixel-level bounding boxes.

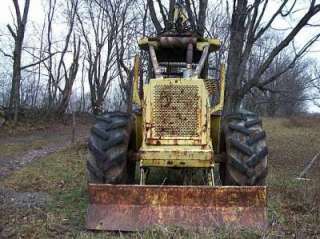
[86,4,268,231]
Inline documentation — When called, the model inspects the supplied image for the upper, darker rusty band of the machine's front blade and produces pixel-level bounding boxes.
[88,184,266,207]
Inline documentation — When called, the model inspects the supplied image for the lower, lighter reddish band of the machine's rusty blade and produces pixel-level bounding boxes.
[86,204,267,231]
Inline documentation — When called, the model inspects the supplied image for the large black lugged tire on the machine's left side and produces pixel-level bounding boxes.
[87,112,134,184]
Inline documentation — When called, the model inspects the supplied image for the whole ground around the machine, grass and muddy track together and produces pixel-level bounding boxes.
[0,117,320,238]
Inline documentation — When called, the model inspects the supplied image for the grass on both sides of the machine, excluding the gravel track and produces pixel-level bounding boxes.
[0,116,320,239]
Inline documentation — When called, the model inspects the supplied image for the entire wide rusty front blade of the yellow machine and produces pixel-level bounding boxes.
[86,184,267,231]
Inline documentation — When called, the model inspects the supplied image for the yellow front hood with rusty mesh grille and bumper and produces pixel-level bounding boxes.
[139,78,213,168]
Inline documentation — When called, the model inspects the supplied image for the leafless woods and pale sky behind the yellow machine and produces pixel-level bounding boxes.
[0,0,320,122]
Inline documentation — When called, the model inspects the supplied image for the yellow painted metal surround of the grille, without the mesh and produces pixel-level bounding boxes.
[139,78,214,168]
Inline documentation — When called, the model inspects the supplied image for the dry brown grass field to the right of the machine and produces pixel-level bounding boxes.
[264,118,320,238]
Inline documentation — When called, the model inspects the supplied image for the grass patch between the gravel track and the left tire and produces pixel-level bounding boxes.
[1,147,87,238]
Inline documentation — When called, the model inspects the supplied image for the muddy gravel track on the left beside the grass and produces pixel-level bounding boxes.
[0,121,92,238]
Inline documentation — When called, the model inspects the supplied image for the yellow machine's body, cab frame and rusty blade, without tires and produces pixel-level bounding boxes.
[86,34,267,231]
